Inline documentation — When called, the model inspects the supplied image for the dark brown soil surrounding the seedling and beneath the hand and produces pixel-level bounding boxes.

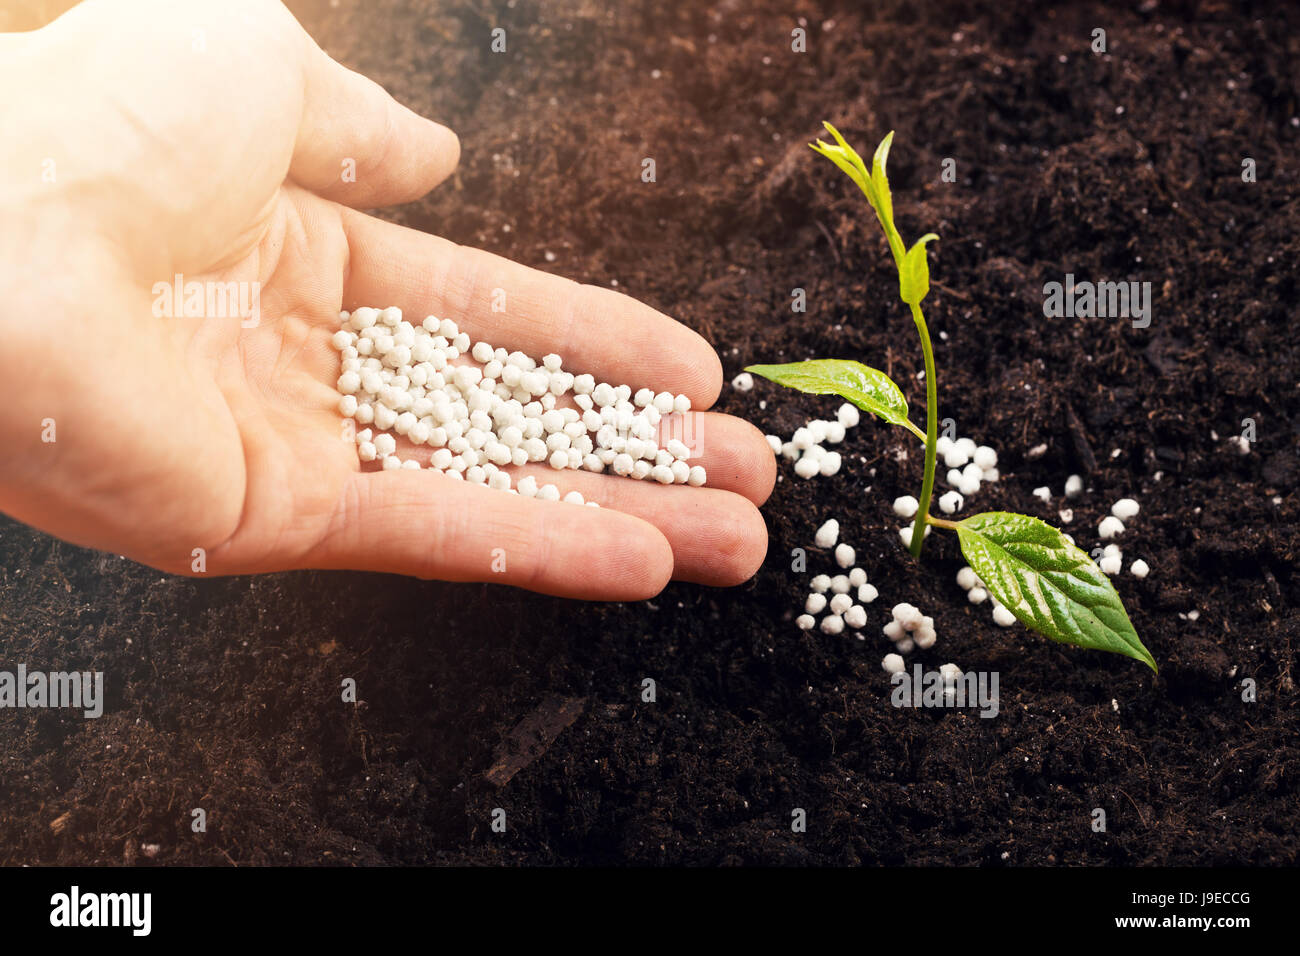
[0,0,1300,865]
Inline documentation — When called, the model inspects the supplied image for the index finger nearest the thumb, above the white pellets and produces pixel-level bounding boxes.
[341,208,723,408]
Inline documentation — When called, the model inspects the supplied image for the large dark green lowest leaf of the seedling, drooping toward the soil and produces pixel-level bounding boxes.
[957,511,1156,670]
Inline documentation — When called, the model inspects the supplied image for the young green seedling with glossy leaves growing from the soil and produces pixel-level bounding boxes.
[746,124,1156,670]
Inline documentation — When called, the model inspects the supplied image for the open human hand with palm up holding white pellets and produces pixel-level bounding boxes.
[0,0,775,600]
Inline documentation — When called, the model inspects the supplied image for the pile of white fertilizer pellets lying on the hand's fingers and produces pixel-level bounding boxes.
[332,308,707,506]
